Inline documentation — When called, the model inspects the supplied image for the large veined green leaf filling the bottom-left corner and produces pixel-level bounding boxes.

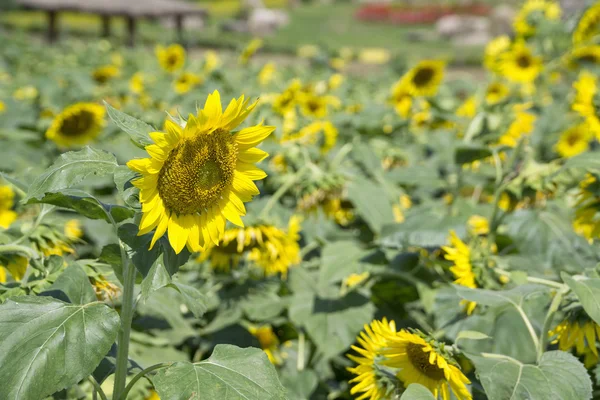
[0,296,119,400]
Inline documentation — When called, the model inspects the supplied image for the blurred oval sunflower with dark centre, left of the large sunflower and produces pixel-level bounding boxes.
[46,103,105,147]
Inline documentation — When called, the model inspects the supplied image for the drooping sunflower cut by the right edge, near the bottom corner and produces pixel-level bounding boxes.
[548,310,600,368]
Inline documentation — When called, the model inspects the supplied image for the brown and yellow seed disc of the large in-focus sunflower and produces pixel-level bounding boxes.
[158,130,237,215]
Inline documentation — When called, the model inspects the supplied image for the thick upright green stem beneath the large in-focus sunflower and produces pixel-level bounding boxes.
[113,247,136,400]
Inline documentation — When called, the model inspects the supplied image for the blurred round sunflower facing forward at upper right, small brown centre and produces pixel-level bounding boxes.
[500,42,543,83]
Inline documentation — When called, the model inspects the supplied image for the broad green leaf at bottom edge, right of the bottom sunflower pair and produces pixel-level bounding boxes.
[470,351,592,400]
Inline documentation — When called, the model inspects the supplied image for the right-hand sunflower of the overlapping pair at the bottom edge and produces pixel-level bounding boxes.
[382,330,472,400]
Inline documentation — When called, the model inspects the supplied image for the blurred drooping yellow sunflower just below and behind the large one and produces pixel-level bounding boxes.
[199,217,300,278]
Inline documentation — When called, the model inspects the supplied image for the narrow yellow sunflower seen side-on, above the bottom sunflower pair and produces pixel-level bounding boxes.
[442,231,477,315]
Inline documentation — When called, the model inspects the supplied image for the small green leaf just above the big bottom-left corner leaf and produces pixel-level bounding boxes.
[43,264,97,304]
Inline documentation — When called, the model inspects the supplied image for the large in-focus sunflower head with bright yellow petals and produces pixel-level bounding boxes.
[127,90,275,253]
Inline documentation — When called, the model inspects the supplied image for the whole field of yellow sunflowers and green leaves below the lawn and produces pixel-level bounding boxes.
[0,0,600,400]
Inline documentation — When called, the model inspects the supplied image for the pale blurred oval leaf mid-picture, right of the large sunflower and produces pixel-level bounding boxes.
[348,177,394,233]
